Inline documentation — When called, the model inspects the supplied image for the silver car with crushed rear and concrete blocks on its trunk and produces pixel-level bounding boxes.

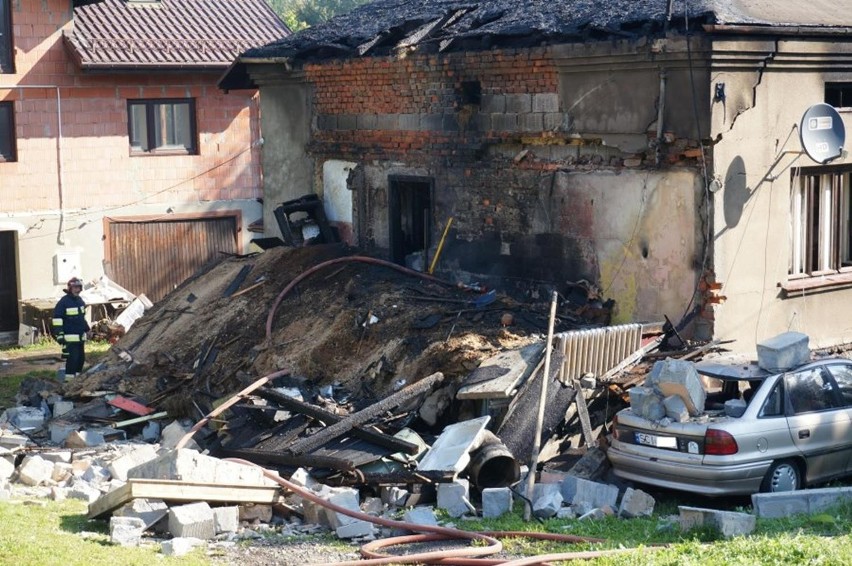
[608,359,852,496]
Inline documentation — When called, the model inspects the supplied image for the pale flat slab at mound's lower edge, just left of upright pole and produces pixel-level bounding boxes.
[456,342,544,399]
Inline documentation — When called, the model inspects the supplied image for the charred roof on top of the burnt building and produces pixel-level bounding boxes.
[236,0,852,64]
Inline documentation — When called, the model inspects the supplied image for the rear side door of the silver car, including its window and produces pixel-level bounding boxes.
[785,366,849,483]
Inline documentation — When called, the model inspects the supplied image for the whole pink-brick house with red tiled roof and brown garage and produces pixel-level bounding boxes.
[0,0,288,341]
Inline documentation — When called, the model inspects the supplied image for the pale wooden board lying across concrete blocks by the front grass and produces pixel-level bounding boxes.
[87,479,279,519]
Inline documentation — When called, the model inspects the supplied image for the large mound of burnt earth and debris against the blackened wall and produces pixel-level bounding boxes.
[64,245,548,417]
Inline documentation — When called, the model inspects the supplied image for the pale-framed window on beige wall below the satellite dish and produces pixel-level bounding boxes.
[790,167,852,277]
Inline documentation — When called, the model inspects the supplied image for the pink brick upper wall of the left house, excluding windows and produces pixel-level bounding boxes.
[0,0,261,213]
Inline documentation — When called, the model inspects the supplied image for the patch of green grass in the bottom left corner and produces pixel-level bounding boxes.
[0,500,210,566]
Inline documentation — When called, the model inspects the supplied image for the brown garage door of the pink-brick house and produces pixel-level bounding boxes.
[105,215,238,302]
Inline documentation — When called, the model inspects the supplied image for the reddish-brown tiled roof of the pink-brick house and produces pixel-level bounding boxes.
[64,0,290,70]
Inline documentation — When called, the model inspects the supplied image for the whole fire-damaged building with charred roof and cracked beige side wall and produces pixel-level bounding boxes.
[220,0,852,351]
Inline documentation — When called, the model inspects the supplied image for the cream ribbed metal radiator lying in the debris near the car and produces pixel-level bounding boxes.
[554,324,642,384]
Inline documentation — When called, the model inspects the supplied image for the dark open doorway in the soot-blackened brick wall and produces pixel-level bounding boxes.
[388,176,432,266]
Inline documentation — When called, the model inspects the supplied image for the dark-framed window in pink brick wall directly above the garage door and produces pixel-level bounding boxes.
[127,98,197,155]
